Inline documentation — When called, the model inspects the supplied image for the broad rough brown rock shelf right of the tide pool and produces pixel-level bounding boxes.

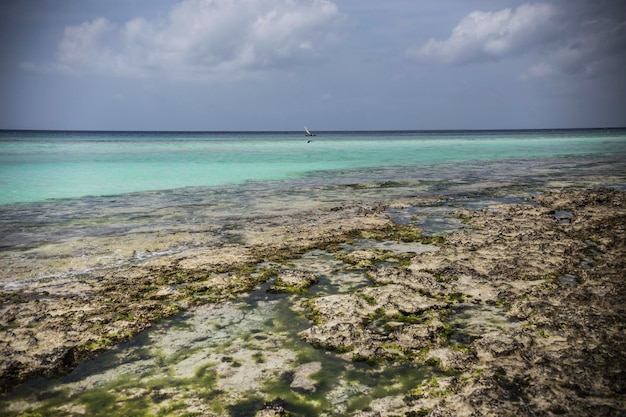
[303,189,626,416]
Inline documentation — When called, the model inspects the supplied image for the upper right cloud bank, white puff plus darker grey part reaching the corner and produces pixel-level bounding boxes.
[405,0,626,79]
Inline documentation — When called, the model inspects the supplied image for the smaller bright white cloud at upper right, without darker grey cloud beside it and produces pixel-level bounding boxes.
[406,3,556,64]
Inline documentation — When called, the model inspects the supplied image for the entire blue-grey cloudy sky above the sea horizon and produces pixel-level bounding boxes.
[0,0,626,130]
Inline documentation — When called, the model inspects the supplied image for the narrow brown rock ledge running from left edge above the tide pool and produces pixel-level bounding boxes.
[0,205,392,391]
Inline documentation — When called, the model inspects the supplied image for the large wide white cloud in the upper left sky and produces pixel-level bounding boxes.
[28,0,339,78]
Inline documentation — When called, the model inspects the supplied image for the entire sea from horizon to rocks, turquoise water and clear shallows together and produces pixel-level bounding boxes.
[0,129,626,256]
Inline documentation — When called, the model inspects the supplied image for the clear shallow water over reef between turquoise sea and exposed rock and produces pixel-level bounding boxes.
[0,153,626,288]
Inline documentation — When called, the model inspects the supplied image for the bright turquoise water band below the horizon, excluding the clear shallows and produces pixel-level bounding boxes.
[0,129,626,204]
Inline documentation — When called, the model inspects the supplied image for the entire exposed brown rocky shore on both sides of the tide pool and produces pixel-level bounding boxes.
[0,189,626,417]
